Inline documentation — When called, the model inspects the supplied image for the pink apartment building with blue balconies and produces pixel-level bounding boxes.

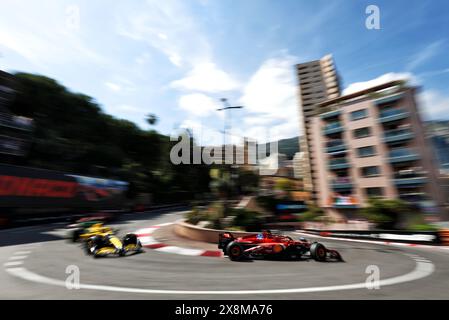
[310,81,444,218]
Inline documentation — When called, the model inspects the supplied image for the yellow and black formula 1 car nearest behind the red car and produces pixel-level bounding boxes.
[85,232,142,258]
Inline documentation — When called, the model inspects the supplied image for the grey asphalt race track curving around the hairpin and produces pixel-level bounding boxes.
[0,212,449,299]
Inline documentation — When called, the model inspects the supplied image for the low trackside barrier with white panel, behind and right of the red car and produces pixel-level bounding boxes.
[304,229,442,245]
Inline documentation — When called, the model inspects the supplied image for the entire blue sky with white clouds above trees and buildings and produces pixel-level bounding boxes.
[0,0,449,144]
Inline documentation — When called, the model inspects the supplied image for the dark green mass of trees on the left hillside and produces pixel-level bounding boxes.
[11,73,209,202]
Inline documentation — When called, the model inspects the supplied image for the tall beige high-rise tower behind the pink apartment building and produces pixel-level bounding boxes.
[296,55,341,200]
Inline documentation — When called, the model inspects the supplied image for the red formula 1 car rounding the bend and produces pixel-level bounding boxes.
[218,231,343,261]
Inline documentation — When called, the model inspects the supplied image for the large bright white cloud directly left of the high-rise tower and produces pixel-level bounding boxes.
[239,54,301,141]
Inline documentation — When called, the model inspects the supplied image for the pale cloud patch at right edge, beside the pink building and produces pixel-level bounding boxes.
[418,89,449,120]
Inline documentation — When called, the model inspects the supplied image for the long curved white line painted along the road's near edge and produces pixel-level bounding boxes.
[6,254,435,295]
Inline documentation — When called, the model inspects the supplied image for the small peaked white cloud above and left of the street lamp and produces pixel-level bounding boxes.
[171,62,239,92]
